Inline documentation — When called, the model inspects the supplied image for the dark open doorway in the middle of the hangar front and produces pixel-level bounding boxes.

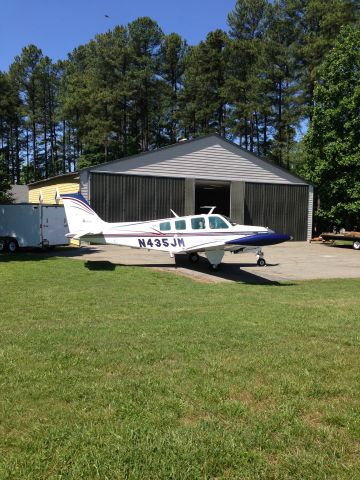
[195,180,230,217]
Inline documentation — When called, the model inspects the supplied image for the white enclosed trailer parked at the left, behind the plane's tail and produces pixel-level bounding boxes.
[0,203,69,252]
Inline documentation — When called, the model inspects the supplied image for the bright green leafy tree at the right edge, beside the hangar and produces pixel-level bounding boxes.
[303,27,360,228]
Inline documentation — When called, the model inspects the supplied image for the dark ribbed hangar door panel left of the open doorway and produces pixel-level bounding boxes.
[90,172,185,222]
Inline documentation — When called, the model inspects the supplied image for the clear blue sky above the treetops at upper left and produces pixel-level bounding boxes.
[0,0,235,71]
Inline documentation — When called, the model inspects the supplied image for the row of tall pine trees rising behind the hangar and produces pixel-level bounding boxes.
[0,0,359,208]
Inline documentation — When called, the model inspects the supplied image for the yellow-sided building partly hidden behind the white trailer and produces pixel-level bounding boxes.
[29,173,80,205]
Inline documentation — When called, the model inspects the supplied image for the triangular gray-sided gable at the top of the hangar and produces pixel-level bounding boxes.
[81,134,309,185]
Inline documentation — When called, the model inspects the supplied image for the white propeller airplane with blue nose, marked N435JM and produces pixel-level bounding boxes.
[61,193,292,271]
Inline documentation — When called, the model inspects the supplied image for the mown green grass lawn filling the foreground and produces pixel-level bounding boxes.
[0,254,360,480]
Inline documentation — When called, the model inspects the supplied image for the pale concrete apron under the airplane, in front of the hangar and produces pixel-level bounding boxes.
[53,242,360,283]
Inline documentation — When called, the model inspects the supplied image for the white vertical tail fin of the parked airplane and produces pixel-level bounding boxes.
[61,193,104,235]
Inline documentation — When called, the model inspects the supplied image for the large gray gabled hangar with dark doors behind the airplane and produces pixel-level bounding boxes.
[29,134,313,240]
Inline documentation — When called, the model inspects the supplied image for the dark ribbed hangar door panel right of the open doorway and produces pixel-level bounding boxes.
[245,183,309,240]
